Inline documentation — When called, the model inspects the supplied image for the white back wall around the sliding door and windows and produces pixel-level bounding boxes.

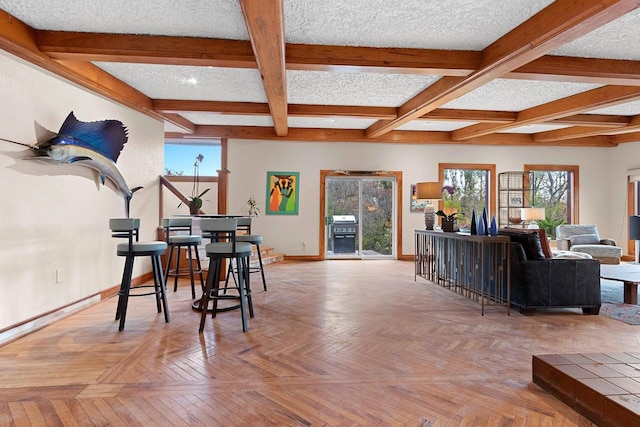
[228,140,640,255]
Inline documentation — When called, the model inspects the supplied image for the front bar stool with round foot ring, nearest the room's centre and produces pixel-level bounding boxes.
[198,218,253,333]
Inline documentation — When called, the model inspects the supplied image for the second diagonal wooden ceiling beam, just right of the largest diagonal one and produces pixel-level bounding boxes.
[452,86,640,140]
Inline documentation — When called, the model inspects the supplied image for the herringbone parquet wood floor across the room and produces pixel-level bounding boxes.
[0,261,640,426]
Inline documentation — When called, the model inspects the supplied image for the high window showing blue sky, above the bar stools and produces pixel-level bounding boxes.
[164,141,221,176]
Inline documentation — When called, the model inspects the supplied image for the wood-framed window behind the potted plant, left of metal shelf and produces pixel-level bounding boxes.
[439,163,496,228]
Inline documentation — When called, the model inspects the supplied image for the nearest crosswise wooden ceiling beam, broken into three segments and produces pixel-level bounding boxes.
[35,30,640,86]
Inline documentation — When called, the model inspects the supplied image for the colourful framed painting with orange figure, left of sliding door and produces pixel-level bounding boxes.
[265,172,300,215]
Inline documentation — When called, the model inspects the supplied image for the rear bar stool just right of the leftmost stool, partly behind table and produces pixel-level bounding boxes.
[162,217,204,298]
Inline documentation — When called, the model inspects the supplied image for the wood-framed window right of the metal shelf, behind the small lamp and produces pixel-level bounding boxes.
[524,165,578,239]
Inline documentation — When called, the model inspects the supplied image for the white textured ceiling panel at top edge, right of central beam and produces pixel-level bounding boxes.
[285,0,552,50]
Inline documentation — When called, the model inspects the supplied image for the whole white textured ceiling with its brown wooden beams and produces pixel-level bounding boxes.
[0,0,640,147]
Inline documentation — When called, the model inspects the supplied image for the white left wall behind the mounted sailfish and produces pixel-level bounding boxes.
[0,53,164,330]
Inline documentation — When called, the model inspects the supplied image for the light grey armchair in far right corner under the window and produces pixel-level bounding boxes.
[556,224,622,264]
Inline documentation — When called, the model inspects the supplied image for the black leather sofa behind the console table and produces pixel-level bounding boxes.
[499,229,601,315]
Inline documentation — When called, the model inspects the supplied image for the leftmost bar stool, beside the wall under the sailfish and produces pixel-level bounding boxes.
[109,218,170,331]
